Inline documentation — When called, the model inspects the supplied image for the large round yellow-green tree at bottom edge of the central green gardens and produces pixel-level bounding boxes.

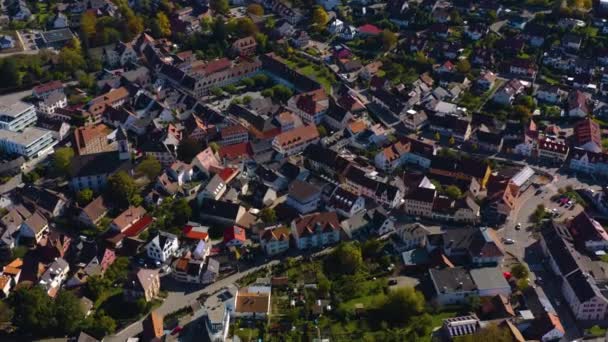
[378,286,425,325]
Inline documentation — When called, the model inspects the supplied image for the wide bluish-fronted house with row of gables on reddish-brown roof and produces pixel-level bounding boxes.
[291,212,341,249]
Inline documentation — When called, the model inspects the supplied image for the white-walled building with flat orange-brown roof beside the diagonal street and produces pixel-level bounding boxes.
[232,285,271,320]
